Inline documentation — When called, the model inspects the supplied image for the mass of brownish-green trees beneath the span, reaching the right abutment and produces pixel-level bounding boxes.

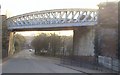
[31,33,73,56]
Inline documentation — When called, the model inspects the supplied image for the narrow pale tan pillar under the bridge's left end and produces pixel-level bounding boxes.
[8,32,15,56]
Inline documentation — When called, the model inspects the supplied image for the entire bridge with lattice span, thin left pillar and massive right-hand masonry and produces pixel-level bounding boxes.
[1,2,120,71]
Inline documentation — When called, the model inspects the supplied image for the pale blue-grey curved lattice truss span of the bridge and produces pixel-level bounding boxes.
[7,9,97,29]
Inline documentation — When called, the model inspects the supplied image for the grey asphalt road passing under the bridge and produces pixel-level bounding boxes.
[2,50,81,73]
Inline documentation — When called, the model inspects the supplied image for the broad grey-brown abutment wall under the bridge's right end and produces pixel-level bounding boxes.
[73,27,95,61]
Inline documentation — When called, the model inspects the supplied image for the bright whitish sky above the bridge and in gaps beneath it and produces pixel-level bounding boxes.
[0,0,117,35]
